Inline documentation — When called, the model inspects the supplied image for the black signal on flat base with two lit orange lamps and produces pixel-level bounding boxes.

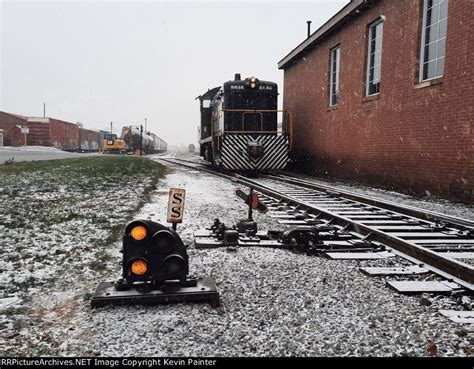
[91,220,219,307]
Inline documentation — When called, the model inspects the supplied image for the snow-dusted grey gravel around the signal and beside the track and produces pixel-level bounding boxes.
[0,158,474,356]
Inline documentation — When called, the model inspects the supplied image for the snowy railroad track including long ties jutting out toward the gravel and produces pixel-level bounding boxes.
[163,158,474,294]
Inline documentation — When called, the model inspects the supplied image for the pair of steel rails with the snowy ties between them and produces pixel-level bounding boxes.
[158,159,474,292]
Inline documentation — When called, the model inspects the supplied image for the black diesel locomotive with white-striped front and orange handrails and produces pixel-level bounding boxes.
[198,74,292,171]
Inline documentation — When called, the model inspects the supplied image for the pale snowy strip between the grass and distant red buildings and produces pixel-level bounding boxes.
[0,146,98,165]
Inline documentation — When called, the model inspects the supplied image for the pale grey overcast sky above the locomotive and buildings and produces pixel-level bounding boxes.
[0,0,349,145]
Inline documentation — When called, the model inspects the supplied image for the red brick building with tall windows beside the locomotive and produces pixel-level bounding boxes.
[278,0,474,201]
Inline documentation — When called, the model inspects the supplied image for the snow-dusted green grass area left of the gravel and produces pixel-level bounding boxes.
[0,157,165,357]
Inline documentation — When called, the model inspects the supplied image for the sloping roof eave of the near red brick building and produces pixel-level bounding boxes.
[278,0,371,69]
